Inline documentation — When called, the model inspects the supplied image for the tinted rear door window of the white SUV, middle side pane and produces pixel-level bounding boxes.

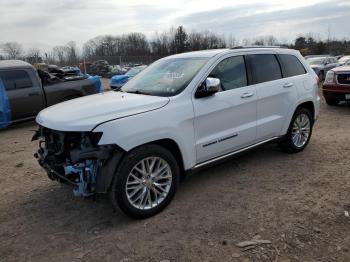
[248,54,282,84]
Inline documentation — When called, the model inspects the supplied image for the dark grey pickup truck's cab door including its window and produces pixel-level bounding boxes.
[0,69,45,120]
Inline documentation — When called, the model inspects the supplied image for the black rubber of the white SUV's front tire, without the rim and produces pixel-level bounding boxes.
[109,145,180,218]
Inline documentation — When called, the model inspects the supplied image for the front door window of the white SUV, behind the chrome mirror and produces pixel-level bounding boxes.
[209,56,248,91]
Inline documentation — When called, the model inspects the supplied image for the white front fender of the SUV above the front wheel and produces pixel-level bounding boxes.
[93,97,196,170]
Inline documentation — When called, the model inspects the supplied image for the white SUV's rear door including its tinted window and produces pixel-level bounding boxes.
[247,53,297,141]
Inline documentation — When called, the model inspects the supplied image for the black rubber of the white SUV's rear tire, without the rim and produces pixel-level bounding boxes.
[279,107,314,153]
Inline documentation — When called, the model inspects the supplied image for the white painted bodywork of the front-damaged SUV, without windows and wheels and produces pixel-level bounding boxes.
[37,48,320,170]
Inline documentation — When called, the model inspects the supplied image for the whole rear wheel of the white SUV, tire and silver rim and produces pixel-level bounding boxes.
[280,108,313,153]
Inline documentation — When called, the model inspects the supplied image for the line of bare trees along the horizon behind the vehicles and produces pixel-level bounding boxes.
[0,26,350,65]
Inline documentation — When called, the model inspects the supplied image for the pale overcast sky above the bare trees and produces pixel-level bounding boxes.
[0,0,350,52]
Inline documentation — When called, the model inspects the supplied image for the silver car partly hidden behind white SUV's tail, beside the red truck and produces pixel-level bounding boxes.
[306,56,339,81]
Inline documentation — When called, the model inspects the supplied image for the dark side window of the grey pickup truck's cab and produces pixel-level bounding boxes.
[0,70,33,90]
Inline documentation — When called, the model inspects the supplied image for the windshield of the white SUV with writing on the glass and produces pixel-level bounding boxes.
[121,58,208,96]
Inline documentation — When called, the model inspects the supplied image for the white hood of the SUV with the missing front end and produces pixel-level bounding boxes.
[36,91,169,131]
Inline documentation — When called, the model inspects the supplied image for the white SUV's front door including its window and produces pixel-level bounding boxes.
[193,56,256,163]
